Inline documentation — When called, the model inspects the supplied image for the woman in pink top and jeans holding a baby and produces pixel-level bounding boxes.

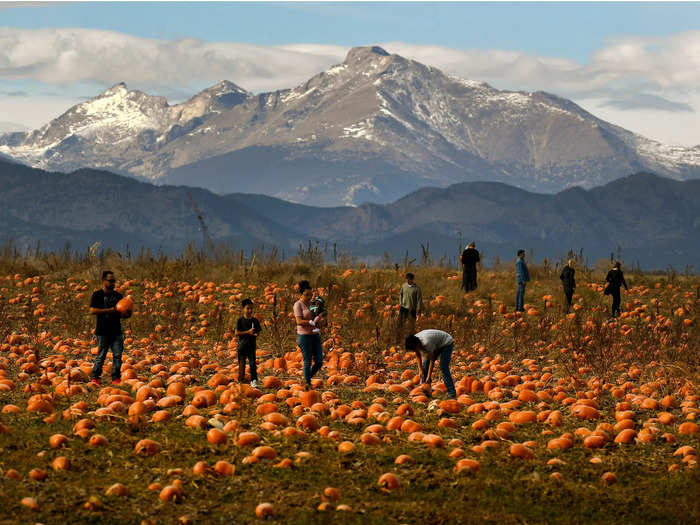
[294,281,323,390]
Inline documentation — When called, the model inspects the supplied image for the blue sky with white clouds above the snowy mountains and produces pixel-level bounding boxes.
[0,2,700,144]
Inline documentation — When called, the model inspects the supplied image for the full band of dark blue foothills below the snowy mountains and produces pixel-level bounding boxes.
[0,160,700,269]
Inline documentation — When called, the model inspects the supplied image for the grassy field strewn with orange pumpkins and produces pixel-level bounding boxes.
[0,254,700,524]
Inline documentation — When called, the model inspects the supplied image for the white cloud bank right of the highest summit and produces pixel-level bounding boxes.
[386,31,700,102]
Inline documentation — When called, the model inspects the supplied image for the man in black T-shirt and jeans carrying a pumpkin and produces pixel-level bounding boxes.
[90,270,124,385]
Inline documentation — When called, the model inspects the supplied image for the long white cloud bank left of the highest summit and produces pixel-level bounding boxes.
[0,28,337,91]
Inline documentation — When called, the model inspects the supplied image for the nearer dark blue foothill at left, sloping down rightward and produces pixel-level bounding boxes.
[0,162,303,250]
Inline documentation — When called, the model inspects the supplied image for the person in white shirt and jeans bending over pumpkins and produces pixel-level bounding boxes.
[405,329,457,399]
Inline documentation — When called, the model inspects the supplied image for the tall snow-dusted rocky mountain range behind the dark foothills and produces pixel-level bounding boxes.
[0,46,700,207]
